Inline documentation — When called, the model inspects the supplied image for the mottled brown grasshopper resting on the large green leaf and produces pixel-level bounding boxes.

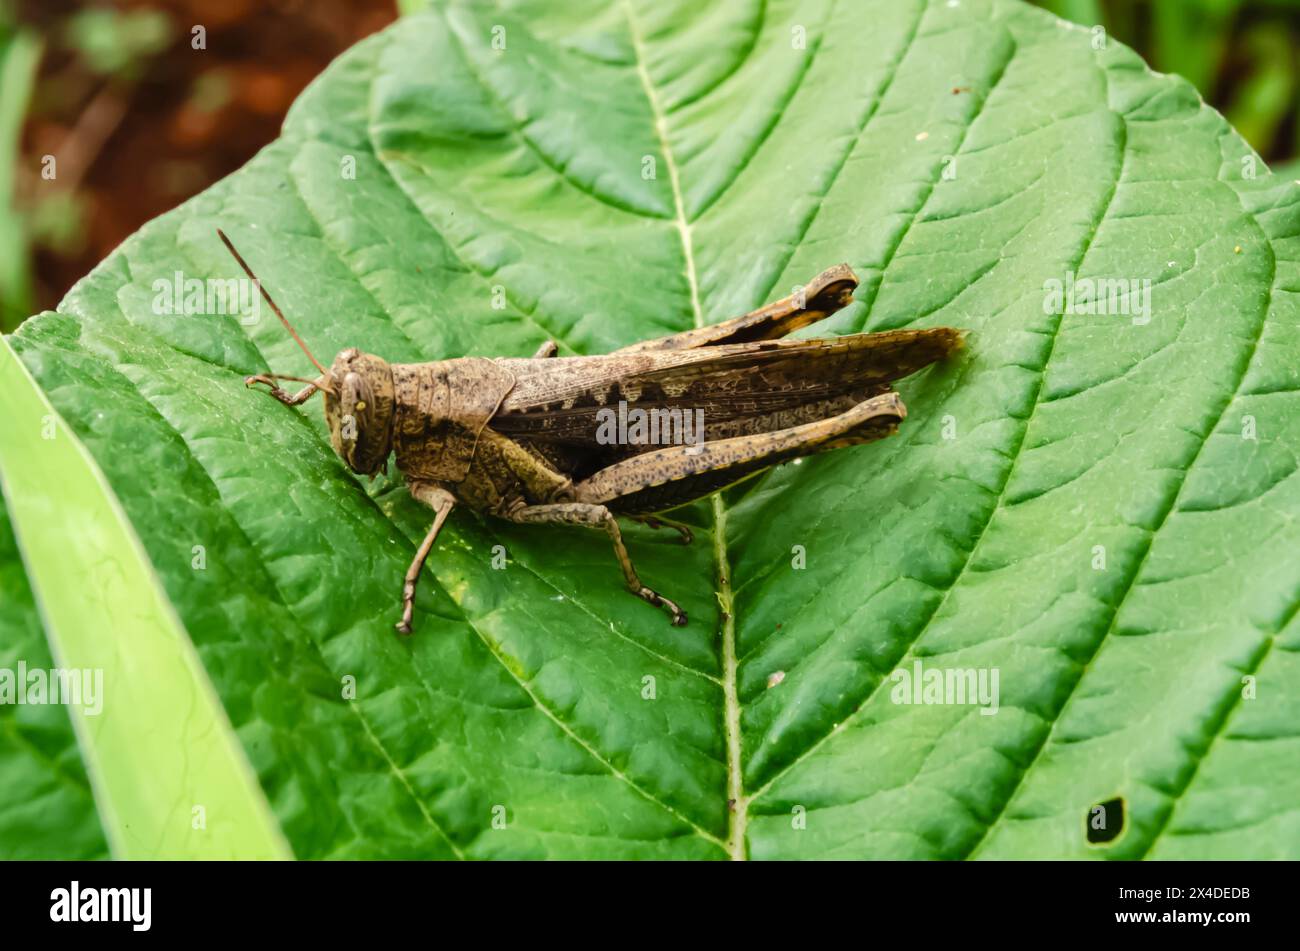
[217,230,962,634]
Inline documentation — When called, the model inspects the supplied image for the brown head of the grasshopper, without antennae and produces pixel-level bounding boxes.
[325,347,393,476]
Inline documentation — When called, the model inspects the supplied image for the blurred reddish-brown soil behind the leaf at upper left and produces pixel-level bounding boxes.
[18,0,397,311]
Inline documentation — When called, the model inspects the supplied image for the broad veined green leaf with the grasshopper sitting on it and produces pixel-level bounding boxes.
[2,0,1300,859]
